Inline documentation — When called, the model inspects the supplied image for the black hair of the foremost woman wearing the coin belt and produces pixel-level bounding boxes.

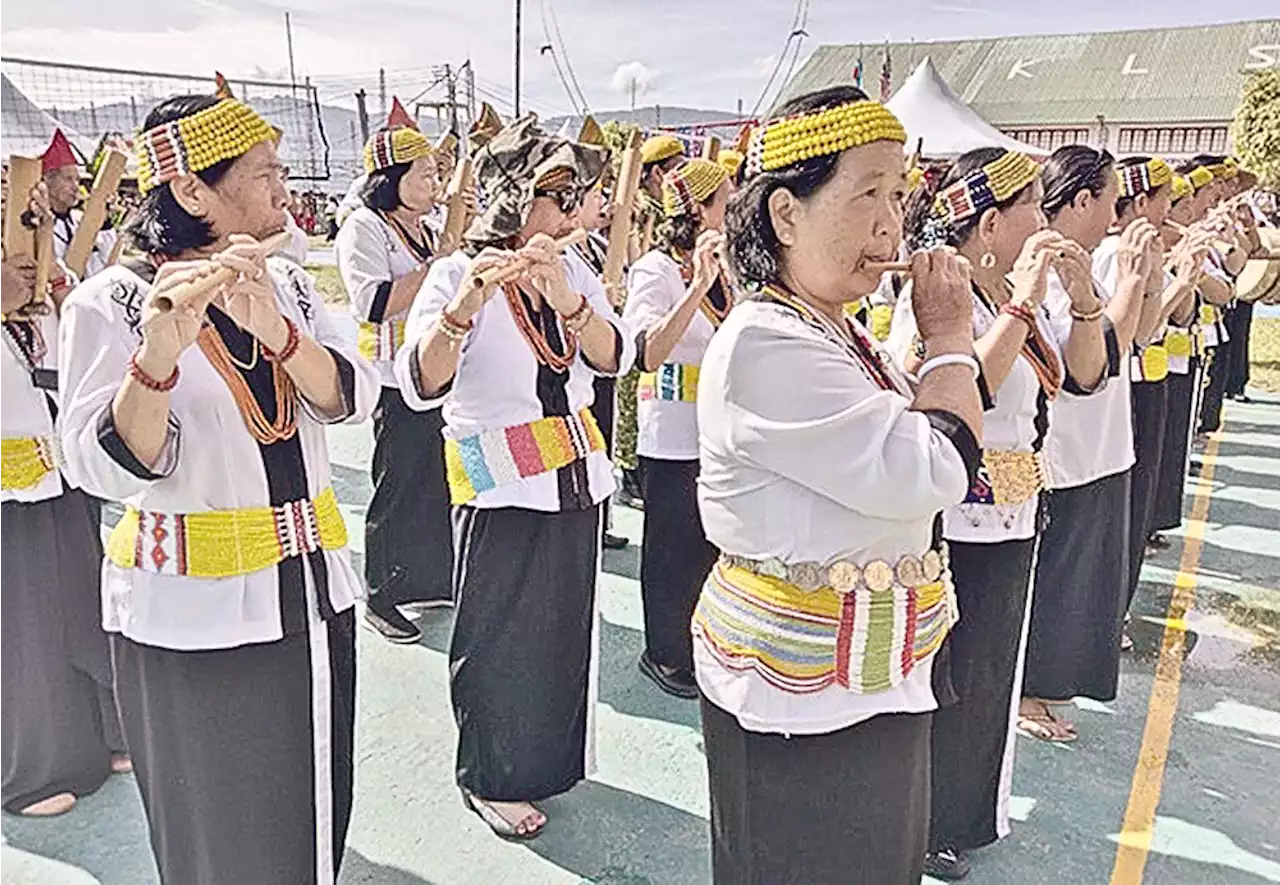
[724,86,867,284]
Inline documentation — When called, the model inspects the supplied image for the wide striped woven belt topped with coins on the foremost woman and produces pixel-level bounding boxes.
[692,548,959,694]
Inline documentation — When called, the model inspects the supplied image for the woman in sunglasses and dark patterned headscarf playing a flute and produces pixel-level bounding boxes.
[396,117,635,839]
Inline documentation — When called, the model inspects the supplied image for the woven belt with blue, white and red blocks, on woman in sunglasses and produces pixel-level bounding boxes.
[444,409,604,505]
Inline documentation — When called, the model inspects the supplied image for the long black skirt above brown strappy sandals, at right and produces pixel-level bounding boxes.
[1023,470,1130,701]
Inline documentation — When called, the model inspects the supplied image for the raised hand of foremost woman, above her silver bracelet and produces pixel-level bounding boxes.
[911,248,973,353]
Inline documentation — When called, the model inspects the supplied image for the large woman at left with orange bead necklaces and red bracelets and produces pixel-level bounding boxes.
[59,96,379,885]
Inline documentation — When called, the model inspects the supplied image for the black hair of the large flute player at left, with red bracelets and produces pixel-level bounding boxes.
[124,95,236,255]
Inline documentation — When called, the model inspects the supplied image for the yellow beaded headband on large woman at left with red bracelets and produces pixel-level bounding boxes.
[137,99,275,193]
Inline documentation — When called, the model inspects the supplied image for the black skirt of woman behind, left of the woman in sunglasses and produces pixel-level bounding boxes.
[365,387,453,606]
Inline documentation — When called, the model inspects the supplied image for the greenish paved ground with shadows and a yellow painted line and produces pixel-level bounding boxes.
[0,400,1280,885]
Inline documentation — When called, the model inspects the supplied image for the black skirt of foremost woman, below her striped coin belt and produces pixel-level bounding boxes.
[701,698,931,885]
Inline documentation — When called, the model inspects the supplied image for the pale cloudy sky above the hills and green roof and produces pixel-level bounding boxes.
[0,0,1277,114]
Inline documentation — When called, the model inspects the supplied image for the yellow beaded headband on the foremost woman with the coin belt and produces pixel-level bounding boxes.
[746,101,906,178]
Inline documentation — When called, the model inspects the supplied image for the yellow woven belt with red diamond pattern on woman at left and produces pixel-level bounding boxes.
[106,488,347,578]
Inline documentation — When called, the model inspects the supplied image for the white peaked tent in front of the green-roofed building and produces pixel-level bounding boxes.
[887,56,1047,159]
